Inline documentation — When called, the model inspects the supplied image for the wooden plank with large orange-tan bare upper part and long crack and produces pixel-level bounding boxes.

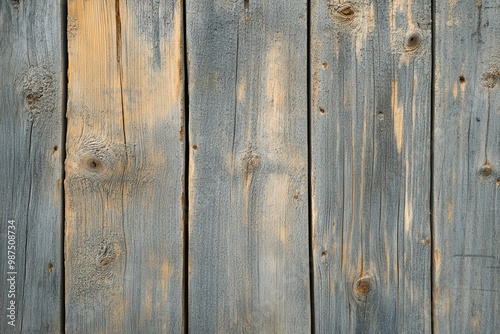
[65,0,185,333]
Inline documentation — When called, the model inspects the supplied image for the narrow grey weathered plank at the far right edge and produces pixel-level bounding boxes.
[433,0,500,333]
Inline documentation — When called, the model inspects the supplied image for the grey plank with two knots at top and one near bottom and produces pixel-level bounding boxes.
[311,0,432,333]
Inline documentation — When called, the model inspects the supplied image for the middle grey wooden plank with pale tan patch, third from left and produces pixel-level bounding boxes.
[186,0,311,333]
